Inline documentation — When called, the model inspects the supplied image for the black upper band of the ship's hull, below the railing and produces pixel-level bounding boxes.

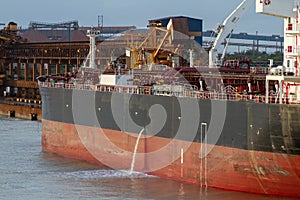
[41,87,300,155]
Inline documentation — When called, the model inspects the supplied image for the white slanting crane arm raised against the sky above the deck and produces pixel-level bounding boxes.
[209,0,255,67]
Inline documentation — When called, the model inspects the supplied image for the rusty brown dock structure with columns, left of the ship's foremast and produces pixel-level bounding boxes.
[0,21,135,102]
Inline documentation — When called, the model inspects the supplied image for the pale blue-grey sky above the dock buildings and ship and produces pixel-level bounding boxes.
[0,0,283,35]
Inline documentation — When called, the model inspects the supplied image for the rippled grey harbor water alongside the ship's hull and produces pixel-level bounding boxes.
[0,117,296,200]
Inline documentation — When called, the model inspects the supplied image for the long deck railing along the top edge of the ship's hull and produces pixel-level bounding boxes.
[39,82,300,104]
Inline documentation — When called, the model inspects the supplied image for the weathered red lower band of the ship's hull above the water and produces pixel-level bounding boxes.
[42,120,300,197]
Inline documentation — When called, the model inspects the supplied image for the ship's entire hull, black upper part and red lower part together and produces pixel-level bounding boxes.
[41,88,300,197]
